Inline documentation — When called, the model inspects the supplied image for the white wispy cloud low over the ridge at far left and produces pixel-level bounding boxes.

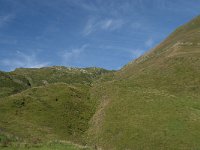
[0,51,50,70]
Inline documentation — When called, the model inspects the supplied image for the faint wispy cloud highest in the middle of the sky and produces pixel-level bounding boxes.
[83,18,125,35]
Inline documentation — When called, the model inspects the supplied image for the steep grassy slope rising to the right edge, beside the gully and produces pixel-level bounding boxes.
[88,17,200,150]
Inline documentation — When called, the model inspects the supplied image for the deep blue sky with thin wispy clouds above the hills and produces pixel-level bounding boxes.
[0,0,200,71]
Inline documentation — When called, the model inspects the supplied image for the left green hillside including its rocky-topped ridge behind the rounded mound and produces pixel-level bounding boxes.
[0,66,112,148]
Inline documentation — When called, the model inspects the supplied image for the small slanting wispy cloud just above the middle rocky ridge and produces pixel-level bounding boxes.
[62,44,88,64]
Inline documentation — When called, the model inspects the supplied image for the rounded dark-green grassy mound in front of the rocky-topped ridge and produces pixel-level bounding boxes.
[0,83,96,143]
